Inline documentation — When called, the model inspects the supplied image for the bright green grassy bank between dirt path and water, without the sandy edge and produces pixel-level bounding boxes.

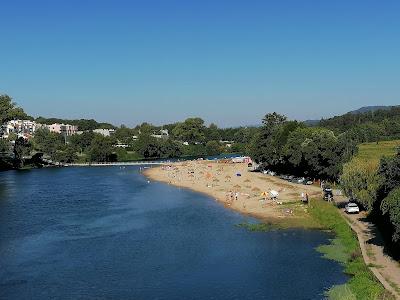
[310,200,393,300]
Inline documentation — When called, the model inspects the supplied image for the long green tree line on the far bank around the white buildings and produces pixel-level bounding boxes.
[0,95,257,168]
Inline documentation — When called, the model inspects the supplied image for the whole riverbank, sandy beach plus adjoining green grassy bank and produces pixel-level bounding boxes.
[144,161,393,299]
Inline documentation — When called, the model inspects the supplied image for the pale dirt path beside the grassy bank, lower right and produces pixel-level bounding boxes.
[337,198,400,299]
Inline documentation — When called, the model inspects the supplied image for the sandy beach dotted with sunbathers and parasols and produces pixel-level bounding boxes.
[144,160,321,221]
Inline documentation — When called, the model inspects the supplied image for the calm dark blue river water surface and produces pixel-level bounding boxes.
[0,167,346,300]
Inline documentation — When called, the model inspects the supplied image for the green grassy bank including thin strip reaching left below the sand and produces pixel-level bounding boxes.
[238,200,394,300]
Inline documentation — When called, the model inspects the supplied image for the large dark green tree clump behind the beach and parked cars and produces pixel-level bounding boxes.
[249,113,357,180]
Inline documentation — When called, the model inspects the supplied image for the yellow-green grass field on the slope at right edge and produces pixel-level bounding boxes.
[356,140,400,163]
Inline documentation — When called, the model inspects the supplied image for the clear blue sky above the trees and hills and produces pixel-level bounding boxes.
[0,0,400,126]
